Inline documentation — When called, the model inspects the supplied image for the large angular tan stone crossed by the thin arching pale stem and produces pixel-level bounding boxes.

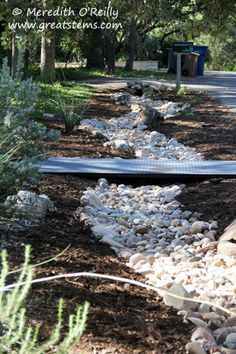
[164,283,196,310]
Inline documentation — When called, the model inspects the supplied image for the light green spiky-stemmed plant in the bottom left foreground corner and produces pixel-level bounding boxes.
[0,246,89,354]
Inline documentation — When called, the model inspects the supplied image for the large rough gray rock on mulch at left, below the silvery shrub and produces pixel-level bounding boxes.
[4,190,55,222]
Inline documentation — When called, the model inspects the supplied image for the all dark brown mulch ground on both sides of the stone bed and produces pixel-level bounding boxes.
[1,87,236,354]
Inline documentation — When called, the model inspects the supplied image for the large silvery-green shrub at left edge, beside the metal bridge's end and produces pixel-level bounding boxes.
[0,54,59,192]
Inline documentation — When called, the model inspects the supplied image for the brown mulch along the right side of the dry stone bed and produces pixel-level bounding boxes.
[151,91,236,233]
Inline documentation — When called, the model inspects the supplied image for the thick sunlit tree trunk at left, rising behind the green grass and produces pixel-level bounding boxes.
[40,31,56,83]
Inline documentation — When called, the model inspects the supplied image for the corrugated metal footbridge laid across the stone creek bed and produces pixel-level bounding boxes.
[37,157,236,178]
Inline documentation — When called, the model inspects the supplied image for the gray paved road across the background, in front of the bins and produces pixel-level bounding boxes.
[80,71,236,113]
